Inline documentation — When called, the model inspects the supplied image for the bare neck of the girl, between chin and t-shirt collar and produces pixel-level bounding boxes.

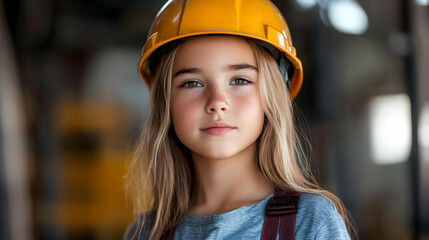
[189,143,273,216]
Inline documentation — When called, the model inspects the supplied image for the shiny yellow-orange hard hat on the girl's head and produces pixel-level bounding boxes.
[138,0,303,99]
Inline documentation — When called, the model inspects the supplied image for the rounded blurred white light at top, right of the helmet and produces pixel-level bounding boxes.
[328,0,368,35]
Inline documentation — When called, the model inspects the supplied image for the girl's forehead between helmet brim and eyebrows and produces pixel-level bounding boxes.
[174,36,256,70]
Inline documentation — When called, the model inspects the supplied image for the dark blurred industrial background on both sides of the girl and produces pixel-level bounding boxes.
[0,0,429,240]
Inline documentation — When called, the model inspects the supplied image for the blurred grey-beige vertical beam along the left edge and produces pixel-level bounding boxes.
[0,2,32,240]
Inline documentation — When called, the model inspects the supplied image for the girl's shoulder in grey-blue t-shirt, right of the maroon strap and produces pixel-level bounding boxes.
[296,193,350,239]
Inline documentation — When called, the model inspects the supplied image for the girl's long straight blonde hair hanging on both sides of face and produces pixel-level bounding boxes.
[126,40,353,239]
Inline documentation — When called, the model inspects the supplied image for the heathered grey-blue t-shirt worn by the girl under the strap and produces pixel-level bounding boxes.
[125,193,350,240]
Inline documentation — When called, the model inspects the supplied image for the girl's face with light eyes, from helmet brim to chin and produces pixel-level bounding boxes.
[171,36,264,159]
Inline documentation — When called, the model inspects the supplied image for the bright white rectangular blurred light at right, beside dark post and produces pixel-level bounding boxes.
[369,94,411,164]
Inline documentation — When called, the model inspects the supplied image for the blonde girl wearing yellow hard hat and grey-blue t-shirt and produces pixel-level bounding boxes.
[125,0,350,239]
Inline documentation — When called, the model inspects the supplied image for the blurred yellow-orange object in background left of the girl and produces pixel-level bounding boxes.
[54,102,132,239]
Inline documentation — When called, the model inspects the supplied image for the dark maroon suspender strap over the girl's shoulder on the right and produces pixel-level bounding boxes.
[261,191,299,240]
